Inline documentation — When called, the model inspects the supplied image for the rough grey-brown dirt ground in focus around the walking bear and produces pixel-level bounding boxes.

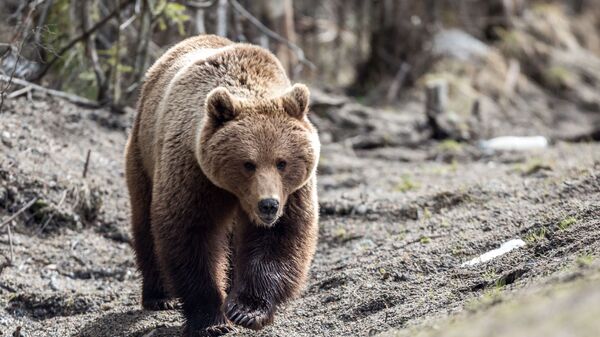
[0,98,600,337]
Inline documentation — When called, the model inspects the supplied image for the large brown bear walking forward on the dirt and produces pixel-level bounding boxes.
[125,35,320,336]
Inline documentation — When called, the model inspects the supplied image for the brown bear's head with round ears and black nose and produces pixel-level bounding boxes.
[196,84,320,226]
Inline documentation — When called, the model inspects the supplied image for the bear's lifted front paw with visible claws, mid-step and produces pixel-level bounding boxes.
[225,300,273,330]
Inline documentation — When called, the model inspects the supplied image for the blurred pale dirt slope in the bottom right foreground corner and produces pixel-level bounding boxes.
[381,266,600,337]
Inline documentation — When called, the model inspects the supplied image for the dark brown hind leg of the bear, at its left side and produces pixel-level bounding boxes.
[125,140,176,310]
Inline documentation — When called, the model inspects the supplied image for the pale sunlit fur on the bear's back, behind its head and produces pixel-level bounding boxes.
[134,35,290,177]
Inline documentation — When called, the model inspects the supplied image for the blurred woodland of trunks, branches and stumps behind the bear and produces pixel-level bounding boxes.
[0,0,600,143]
